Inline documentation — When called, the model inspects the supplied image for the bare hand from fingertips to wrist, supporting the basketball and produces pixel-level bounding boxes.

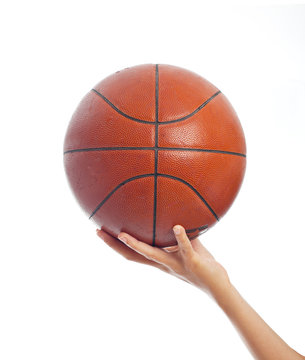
[97,225,230,301]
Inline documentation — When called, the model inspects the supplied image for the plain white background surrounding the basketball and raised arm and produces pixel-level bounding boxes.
[0,0,305,360]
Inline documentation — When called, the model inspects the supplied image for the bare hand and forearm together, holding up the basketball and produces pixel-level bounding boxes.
[97,225,305,360]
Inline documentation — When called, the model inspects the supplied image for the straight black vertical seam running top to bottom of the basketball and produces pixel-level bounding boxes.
[152,64,159,246]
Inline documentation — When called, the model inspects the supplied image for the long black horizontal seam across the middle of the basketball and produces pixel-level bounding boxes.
[64,146,246,157]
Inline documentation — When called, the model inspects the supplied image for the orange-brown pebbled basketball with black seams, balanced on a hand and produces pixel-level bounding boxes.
[64,64,246,247]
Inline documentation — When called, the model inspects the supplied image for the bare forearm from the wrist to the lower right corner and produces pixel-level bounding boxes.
[215,284,305,360]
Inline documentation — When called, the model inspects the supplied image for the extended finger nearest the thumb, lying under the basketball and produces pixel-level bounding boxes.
[118,233,171,266]
